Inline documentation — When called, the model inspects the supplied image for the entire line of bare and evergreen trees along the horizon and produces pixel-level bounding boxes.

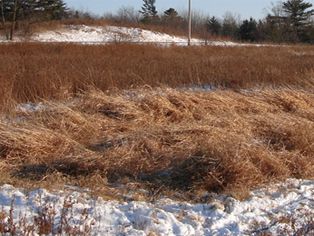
[0,0,314,43]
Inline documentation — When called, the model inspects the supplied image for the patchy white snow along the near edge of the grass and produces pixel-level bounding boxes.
[0,179,314,235]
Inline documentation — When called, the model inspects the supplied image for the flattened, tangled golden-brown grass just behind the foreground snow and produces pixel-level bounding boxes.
[0,88,314,200]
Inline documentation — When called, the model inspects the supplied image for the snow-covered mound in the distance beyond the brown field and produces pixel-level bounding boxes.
[0,25,247,46]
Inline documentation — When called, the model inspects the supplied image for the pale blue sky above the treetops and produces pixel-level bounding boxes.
[65,0,314,18]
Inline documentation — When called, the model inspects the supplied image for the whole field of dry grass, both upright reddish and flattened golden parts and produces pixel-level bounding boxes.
[0,44,314,201]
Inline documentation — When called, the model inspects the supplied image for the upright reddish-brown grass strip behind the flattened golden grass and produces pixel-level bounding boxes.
[0,44,314,109]
